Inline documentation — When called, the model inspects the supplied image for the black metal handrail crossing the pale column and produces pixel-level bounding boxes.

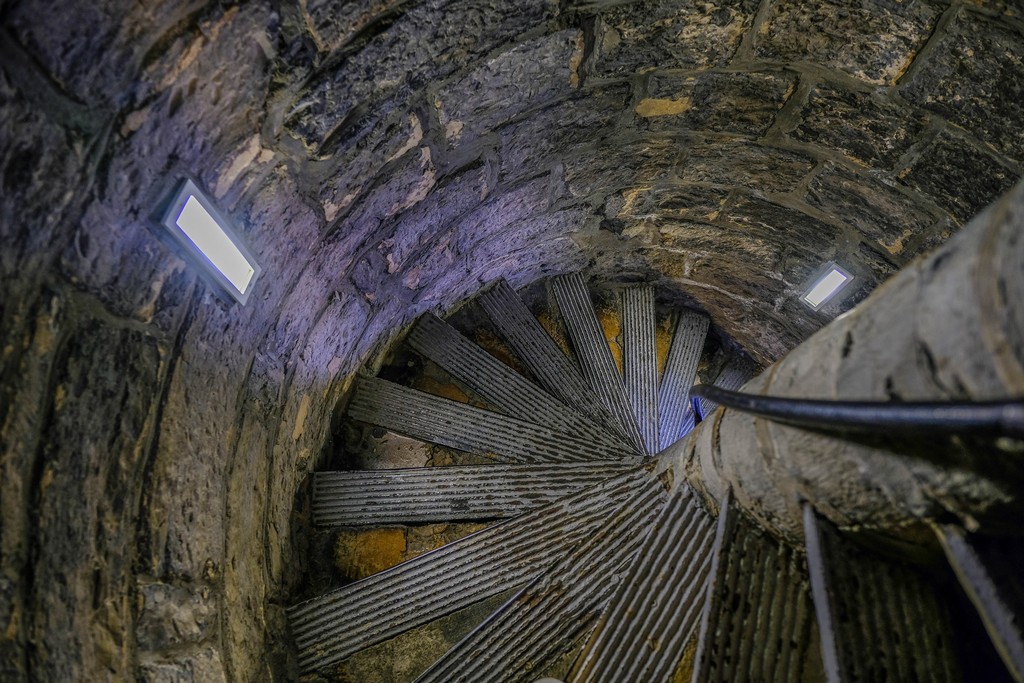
[690,384,1024,438]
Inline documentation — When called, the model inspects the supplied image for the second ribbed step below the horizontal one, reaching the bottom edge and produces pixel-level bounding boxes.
[417,479,668,683]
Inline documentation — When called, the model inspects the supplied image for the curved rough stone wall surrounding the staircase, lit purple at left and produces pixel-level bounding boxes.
[0,0,1024,681]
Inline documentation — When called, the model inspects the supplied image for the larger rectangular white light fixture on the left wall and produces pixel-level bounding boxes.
[162,179,260,304]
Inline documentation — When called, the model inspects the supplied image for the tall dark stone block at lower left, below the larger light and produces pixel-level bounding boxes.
[25,315,168,681]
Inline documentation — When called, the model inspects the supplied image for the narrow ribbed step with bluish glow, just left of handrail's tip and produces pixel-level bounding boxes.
[657,311,711,449]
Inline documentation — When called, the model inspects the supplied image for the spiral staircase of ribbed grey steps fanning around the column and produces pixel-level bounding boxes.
[289,273,1024,683]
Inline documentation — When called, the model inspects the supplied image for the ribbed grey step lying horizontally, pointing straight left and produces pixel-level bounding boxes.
[312,459,639,526]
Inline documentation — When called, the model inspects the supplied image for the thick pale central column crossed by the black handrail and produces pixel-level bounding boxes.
[662,183,1024,542]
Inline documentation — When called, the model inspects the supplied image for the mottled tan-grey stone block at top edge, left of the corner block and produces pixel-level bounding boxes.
[755,0,942,85]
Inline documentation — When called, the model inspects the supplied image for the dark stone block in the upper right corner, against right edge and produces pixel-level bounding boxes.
[900,11,1024,162]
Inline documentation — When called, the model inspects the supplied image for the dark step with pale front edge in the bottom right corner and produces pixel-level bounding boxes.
[936,525,1024,681]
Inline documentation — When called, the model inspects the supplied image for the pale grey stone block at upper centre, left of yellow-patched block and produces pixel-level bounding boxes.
[434,30,583,145]
